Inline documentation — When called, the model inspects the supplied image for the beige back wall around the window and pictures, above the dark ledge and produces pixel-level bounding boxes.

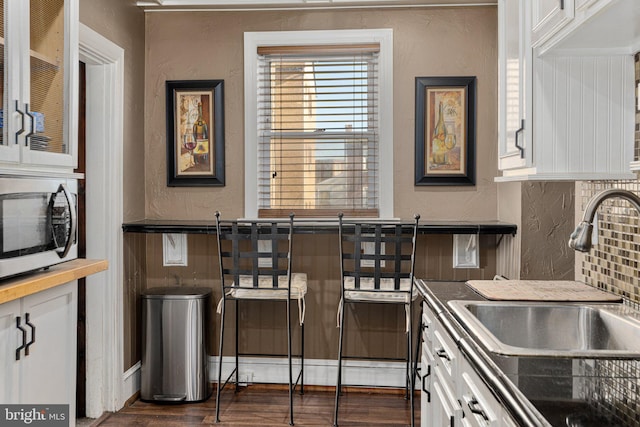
[145,6,497,219]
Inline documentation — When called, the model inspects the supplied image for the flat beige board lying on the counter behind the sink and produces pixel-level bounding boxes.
[467,280,622,302]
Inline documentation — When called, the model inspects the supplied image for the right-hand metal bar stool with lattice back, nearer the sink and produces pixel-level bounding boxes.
[333,213,420,426]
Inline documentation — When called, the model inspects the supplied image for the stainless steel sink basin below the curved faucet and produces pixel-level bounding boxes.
[448,301,640,358]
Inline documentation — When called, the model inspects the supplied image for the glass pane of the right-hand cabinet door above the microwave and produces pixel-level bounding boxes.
[27,0,69,154]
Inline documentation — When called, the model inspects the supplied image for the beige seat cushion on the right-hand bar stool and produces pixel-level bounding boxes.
[344,277,418,304]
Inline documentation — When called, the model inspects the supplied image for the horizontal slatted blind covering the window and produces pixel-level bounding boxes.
[257,44,380,217]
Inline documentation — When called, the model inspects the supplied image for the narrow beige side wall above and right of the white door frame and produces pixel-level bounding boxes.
[80,0,145,221]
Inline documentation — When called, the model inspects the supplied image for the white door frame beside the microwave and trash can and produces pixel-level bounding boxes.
[79,23,125,418]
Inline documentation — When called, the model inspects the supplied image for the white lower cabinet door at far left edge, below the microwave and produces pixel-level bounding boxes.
[0,300,22,404]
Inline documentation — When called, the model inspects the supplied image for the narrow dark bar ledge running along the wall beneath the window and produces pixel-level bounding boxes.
[122,218,518,235]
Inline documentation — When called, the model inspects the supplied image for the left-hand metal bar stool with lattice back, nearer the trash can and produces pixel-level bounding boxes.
[216,212,307,425]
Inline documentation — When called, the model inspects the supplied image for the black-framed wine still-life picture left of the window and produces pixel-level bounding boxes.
[166,80,224,187]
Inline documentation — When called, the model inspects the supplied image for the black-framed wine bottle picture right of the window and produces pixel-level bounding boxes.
[415,77,476,185]
